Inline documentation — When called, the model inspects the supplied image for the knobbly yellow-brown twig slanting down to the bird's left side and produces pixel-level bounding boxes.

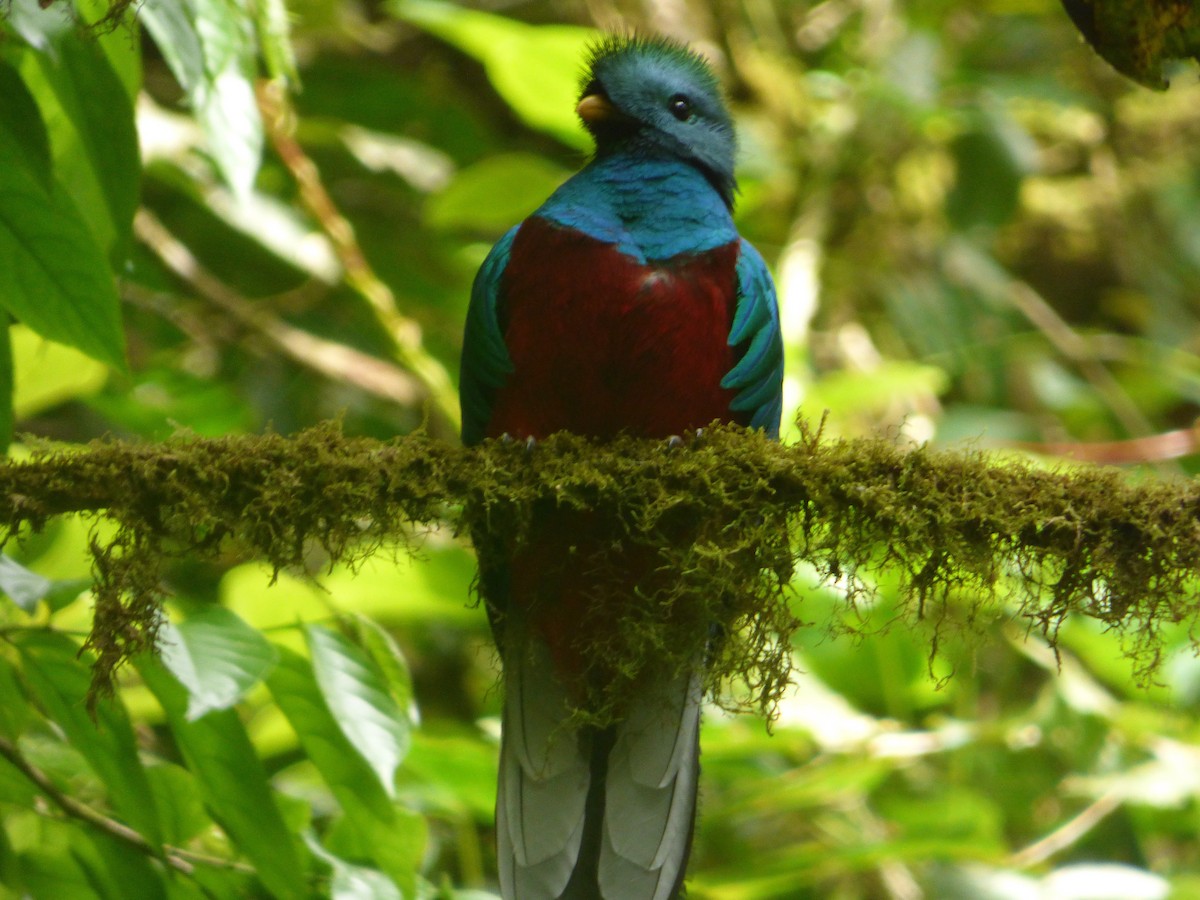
[257,80,460,430]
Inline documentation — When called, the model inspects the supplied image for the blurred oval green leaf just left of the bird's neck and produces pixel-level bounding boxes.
[425,154,570,232]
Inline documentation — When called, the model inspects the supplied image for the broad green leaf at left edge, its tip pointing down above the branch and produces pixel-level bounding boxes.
[0,64,125,368]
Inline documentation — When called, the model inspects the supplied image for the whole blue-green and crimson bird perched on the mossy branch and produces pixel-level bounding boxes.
[460,35,784,900]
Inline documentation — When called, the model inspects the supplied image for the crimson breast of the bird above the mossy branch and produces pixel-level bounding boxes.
[487,218,740,438]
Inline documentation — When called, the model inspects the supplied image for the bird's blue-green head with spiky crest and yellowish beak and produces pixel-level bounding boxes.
[576,36,737,208]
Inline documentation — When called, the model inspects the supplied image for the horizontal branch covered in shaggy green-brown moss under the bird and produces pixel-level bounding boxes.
[0,424,1200,709]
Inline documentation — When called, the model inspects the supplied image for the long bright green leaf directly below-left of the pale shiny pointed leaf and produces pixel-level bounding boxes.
[266,648,425,895]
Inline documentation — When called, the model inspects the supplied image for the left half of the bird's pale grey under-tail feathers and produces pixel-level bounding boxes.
[496,640,589,900]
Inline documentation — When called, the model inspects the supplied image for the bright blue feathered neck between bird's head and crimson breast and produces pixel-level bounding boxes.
[535,154,737,260]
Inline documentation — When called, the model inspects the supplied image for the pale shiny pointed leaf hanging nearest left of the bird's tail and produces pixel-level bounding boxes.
[305,625,412,796]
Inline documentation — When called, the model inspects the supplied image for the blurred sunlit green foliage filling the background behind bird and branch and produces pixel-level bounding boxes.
[0,0,1200,900]
